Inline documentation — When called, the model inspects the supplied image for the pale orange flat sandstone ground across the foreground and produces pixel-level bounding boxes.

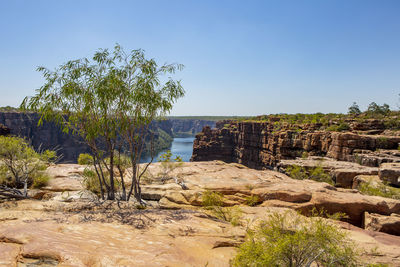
[0,161,400,266]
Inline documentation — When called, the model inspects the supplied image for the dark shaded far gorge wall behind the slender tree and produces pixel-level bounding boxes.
[0,111,215,163]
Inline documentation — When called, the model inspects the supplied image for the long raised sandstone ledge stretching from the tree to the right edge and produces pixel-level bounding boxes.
[143,161,400,229]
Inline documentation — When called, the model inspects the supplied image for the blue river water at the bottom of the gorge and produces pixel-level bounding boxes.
[140,137,194,163]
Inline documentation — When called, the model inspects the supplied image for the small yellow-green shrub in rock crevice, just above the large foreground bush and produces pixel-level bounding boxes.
[202,190,242,226]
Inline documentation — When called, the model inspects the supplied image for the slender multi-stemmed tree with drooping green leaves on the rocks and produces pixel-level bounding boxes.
[21,44,185,202]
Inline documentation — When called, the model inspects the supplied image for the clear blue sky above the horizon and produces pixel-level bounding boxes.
[0,0,400,115]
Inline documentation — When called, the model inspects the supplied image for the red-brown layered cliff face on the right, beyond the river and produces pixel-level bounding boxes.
[191,122,400,169]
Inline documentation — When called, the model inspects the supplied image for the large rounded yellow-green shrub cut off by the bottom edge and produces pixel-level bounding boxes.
[232,212,359,267]
